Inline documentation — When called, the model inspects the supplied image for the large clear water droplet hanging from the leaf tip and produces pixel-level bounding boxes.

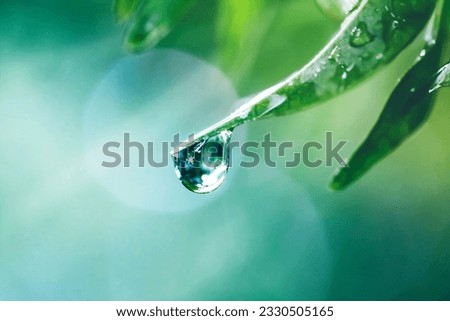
[173,130,232,194]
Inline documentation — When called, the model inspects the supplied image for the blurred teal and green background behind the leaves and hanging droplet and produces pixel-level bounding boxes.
[0,0,450,300]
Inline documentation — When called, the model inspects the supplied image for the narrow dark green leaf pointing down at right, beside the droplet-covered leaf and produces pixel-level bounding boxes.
[331,0,450,190]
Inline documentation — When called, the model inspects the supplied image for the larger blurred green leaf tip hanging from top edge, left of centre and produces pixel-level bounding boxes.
[125,0,198,52]
